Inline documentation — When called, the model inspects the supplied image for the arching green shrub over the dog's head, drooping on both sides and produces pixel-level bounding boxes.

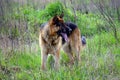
[38,2,74,23]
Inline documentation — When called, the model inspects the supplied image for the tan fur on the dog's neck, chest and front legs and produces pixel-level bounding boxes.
[39,16,62,69]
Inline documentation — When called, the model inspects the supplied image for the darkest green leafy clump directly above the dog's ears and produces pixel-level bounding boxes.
[39,2,65,22]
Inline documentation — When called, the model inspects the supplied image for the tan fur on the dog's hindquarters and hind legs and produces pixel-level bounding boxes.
[63,28,82,63]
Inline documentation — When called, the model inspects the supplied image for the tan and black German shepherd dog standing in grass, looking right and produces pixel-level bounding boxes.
[39,16,85,70]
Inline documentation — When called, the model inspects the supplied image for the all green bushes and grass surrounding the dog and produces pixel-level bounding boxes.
[0,2,120,80]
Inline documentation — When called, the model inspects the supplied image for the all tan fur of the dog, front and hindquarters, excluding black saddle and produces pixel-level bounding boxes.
[39,17,81,70]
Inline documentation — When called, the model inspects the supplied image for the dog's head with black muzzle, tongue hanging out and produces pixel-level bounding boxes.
[50,14,71,41]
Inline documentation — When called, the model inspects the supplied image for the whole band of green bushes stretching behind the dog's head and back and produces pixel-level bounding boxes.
[13,2,107,36]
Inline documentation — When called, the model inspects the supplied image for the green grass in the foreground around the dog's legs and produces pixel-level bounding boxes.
[0,33,120,80]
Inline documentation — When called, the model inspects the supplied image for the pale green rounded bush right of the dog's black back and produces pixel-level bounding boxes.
[76,13,106,36]
